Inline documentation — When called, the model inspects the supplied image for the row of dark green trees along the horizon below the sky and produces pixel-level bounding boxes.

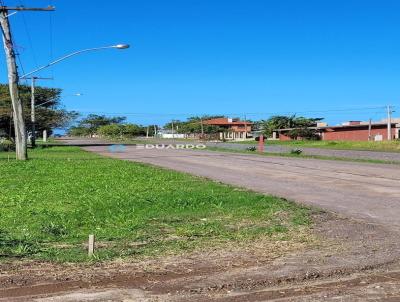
[0,84,322,141]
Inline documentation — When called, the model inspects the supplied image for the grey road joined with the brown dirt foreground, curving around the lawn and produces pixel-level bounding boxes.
[0,140,400,302]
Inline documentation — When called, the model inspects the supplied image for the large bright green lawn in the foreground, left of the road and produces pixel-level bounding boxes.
[0,147,311,262]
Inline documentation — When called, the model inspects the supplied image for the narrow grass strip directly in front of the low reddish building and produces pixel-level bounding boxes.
[238,140,400,152]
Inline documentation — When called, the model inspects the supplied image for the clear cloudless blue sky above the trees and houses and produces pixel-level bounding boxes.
[0,0,400,124]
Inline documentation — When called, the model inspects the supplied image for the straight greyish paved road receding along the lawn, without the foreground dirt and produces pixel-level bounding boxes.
[65,141,400,230]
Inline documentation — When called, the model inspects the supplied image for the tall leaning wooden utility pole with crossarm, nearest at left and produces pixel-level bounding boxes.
[0,6,54,160]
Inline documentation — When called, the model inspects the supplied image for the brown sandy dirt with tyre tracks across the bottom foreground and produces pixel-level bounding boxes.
[0,213,400,301]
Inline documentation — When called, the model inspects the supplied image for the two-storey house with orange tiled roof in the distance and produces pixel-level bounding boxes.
[203,117,252,140]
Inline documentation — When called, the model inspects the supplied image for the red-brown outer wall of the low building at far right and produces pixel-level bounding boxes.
[322,126,396,141]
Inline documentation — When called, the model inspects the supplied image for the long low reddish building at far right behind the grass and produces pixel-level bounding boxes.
[275,120,400,141]
